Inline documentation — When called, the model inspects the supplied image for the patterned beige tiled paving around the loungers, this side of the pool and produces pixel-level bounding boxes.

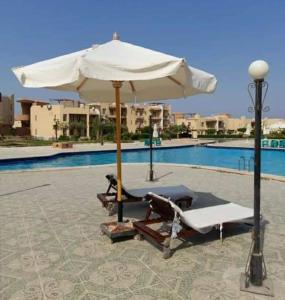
[0,165,285,300]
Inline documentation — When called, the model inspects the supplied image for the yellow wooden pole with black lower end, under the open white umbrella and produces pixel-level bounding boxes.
[113,81,123,223]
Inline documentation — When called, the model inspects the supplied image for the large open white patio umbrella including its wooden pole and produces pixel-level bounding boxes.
[12,34,217,222]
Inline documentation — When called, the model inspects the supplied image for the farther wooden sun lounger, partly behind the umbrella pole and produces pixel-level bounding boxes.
[97,174,197,214]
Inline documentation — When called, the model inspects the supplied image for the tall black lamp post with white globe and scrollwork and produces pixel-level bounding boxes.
[241,60,272,295]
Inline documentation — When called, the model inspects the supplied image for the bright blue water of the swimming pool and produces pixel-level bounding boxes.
[0,147,285,176]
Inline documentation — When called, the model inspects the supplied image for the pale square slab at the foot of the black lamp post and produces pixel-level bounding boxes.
[240,273,274,297]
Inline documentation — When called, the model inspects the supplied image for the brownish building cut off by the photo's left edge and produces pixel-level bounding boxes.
[0,95,14,134]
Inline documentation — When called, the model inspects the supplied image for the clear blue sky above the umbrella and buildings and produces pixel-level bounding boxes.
[0,0,285,118]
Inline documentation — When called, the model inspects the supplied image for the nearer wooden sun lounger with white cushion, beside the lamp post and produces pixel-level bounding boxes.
[133,193,253,258]
